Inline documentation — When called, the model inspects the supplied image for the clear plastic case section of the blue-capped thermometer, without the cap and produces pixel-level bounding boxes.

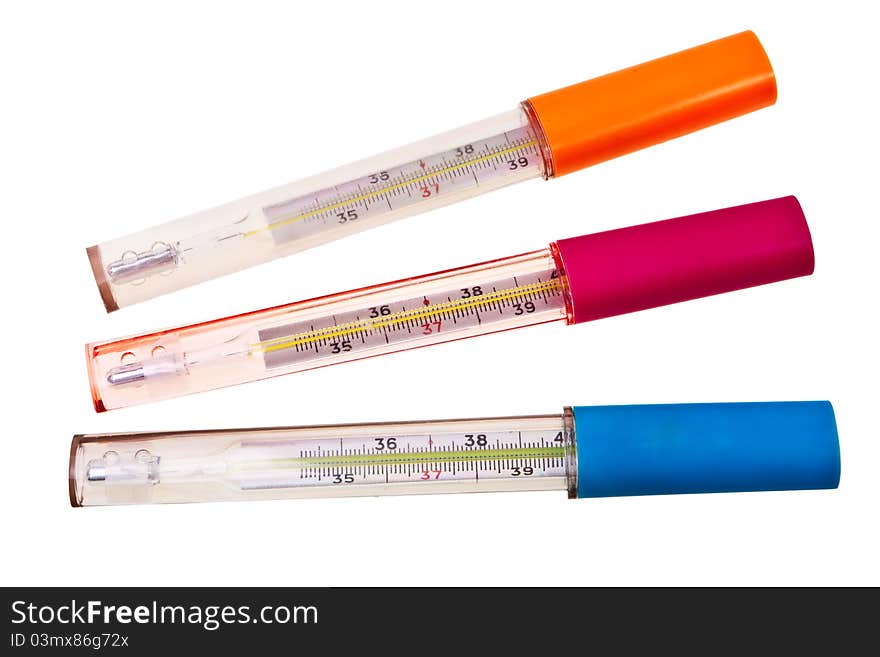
[70,415,576,506]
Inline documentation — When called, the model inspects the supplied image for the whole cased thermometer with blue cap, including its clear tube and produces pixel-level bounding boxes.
[69,402,840,506]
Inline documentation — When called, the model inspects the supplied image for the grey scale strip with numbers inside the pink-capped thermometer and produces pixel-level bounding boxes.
[250,271,565,368]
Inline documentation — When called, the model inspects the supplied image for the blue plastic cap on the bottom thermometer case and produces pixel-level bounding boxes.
[573,401,840,497]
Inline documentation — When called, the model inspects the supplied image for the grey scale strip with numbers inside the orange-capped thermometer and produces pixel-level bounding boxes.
[251,127,542,242]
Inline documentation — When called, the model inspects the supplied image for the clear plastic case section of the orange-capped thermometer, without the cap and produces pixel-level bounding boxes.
[88,107,548,311]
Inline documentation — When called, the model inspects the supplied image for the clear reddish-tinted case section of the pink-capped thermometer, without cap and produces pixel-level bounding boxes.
[86,248,568,411]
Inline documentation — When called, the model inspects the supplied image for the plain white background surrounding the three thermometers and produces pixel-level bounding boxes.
[0,0,880,585]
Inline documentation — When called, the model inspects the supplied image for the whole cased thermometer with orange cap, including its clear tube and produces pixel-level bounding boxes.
[88,32,776,312]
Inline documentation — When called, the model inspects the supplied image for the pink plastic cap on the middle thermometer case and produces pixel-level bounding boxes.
[556,196,813,323]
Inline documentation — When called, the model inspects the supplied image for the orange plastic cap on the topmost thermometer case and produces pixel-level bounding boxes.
[526,32,776,176]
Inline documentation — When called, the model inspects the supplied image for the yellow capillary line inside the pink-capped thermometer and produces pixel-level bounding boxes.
[251,279,561,353]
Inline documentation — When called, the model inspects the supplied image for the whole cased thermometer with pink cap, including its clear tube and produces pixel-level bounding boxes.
[86,196,813,411]
